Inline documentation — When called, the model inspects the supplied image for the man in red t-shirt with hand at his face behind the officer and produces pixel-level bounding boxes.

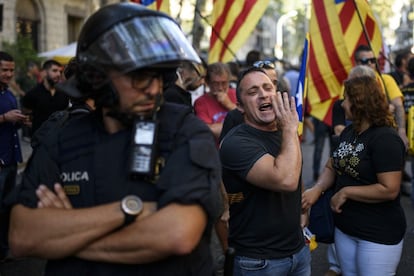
[194,62,236,139]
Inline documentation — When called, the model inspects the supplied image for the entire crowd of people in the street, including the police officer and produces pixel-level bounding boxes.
[0,3,414,276]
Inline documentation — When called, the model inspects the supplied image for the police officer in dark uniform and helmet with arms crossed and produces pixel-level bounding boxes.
[10,2,222,275]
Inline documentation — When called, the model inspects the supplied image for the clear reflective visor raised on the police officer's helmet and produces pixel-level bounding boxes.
[78,16,201,73]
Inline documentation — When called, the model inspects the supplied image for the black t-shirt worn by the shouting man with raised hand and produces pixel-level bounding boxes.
[220,123,304,259]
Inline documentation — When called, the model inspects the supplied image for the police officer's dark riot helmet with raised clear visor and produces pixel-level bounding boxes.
[71,2,201,102]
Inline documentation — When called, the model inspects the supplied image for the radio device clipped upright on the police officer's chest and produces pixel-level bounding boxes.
[129,118,158,176]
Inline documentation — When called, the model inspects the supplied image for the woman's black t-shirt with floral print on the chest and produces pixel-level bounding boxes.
[332,125,406,244]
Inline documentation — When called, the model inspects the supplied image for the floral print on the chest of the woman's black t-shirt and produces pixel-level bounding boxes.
[332,141,365,178]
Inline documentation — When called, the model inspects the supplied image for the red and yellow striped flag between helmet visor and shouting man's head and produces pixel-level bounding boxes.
[208,0,269,63]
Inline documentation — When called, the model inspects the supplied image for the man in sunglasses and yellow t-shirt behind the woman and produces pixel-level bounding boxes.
[354,45,408,149]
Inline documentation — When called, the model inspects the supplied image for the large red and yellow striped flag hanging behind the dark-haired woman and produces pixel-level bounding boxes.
[307,0,382,125]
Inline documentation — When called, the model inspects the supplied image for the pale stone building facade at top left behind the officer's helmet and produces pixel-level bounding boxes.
[0,0,124,52]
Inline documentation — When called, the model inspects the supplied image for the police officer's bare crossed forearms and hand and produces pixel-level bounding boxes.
[9,184,207,264]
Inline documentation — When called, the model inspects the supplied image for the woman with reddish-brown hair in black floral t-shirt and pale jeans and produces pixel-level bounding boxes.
[302,76,406,276]
